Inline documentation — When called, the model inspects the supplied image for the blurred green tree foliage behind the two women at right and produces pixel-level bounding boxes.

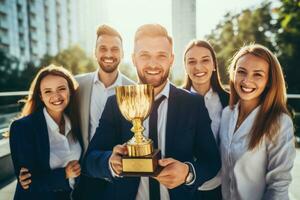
[206,0,300,94]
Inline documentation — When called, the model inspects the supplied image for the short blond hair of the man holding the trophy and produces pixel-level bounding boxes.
[134,24,173,46]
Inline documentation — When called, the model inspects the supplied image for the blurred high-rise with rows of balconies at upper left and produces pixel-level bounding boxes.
[0,0,78,67]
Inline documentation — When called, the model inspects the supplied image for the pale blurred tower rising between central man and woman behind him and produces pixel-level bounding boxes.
[172,0,196,80]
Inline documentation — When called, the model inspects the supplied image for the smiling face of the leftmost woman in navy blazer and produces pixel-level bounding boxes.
[40,75,70,115]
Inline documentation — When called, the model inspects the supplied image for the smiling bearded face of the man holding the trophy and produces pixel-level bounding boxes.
[132,36,174,88]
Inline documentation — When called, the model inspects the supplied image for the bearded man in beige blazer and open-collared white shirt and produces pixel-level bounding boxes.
[76,25,134,152]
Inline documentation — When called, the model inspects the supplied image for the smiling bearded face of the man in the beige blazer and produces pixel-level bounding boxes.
[95,35,123,73]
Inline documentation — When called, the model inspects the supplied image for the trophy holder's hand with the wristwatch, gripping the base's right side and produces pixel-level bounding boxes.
[154,158,189,189]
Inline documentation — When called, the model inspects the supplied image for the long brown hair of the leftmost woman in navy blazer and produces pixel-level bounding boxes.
[20,64,80,140]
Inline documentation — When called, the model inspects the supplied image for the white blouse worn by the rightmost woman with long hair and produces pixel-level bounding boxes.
[220,104,296,200]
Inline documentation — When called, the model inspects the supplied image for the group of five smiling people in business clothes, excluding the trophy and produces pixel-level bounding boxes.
[10,24,295,200]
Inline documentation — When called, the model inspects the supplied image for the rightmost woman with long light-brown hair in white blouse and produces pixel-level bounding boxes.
[220,44,295,200]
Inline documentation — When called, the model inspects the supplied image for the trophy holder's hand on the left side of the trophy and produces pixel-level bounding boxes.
[109,144,128,175]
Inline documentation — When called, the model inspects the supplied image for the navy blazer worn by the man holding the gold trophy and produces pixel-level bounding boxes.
[84,85,221,200]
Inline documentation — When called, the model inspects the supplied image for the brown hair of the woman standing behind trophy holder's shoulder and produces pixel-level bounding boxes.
[183,40,226,93]
